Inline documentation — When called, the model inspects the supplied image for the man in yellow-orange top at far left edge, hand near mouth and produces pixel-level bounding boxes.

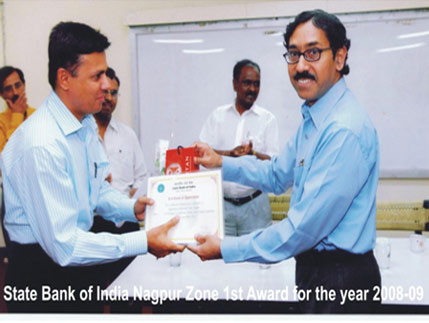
[0,66,35,152]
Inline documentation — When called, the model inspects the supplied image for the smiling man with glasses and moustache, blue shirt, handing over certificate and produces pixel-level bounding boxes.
[189,10,381,313]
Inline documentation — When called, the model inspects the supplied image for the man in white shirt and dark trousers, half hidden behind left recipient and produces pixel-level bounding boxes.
[91,67,147,284]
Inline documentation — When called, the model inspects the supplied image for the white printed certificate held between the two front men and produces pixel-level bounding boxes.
[145,170,224,244]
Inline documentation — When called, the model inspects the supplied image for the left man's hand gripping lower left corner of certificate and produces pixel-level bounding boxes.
[147,216,185,258]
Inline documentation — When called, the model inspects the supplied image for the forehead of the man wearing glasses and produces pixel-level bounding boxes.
[289,20,329,48]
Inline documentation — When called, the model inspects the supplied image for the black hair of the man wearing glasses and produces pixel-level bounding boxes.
[284,9,350,75]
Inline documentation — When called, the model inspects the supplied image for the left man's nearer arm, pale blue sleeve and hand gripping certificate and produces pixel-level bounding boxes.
[8,148,183,266]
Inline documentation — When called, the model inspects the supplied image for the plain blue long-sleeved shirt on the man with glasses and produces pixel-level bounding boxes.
[221,78,379,262]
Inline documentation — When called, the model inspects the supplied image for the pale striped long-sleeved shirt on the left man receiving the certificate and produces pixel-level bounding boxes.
[1,91,147,266]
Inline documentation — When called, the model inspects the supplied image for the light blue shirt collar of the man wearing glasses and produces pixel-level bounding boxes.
[301,77,347,128]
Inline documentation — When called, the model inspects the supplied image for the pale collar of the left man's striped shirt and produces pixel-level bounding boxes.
[47,90,97,136]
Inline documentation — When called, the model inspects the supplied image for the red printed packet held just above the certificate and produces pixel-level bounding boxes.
[165,146,200,175]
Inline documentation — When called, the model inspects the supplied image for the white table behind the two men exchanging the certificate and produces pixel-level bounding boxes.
[105,238,429,311]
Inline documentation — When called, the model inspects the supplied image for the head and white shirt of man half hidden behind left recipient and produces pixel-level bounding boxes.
[94,67,147,197]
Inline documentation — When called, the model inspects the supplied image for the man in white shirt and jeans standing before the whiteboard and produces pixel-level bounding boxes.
[200,59,278,236]
